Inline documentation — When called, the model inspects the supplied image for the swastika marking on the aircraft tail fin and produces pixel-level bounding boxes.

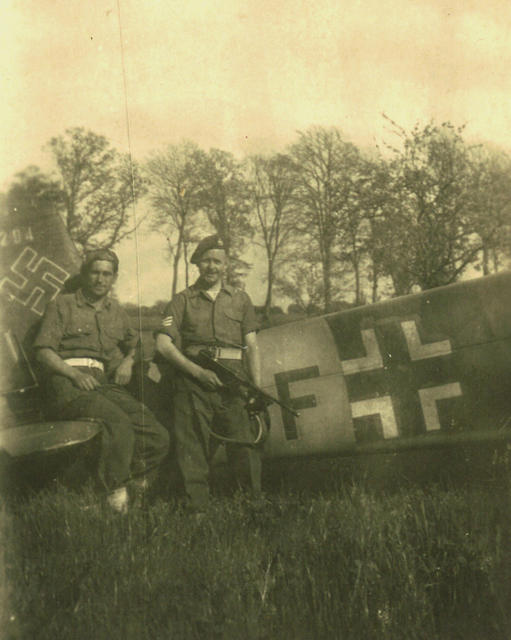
[0,247,69,316]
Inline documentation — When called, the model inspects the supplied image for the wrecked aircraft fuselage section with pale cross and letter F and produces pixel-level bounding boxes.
[260,273,511,456]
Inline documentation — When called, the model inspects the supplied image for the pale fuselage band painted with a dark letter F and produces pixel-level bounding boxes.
[259,318,354,456]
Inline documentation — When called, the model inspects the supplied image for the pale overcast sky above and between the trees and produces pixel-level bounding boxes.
[4,0,511,302]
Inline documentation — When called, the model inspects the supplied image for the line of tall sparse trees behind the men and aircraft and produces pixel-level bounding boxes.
[4,118,511,315]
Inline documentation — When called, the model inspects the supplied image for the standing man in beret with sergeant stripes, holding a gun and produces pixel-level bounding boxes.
[156,235,261,511]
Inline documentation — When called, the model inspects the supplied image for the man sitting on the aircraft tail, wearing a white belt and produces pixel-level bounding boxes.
[34,249,168,512]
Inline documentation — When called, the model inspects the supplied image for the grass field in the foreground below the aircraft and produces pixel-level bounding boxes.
[0,452,511,640]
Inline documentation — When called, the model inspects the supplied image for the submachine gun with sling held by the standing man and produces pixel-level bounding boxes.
[195,349,300,446]
